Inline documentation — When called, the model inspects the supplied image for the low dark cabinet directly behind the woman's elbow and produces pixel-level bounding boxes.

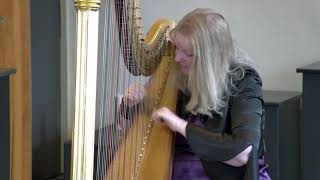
[263,91,301,180]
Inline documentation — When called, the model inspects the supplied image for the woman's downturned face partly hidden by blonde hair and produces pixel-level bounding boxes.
[173,32,194,75]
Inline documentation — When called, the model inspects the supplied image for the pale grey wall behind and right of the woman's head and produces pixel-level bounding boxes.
[141,0,320,91]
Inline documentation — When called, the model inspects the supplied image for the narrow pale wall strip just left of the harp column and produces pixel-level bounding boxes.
[60,0,76,172]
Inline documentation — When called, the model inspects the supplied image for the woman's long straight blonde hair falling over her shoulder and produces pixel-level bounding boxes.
[169,9,254,116]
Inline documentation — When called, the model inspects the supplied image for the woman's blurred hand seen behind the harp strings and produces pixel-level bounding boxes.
[122,83,146,107]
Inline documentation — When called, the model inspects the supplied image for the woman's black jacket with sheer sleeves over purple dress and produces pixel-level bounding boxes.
[178,68,265,180]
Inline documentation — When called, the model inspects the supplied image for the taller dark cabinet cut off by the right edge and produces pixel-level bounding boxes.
[297,62,320,180]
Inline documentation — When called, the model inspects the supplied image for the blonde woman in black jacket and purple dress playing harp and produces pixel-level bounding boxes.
[124,9,271,180]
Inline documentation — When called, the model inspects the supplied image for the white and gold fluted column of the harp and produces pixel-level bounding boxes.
[71,0,101,180]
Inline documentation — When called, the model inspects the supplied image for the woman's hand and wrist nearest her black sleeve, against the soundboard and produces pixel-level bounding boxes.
[151,107,187,137]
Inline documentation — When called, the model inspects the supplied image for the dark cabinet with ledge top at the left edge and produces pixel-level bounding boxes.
[0,67,15,179]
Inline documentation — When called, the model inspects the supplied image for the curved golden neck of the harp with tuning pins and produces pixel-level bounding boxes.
[120,0,175,76]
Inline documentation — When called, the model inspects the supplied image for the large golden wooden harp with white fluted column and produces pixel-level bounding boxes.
[71,0,177,180]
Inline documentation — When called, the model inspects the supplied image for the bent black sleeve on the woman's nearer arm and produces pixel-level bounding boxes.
[186,73,263,161]
